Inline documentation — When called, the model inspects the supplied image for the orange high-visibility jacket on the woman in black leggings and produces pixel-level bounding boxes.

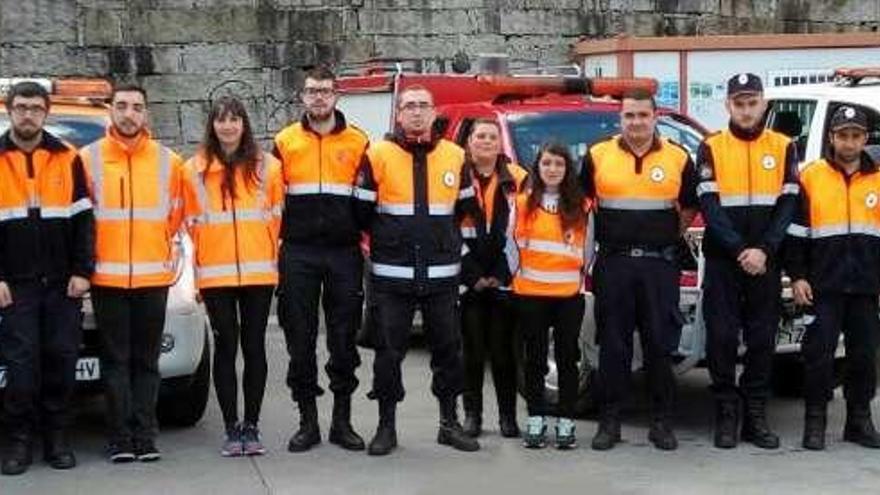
[186,153,284,289]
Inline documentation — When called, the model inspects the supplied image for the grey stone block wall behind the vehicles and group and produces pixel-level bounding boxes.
[0,0,880,150]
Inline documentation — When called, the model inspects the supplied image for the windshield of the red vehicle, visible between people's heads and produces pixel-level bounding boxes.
[508,111,702,164]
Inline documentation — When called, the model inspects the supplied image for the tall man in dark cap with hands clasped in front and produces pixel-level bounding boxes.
[697,74,799,449]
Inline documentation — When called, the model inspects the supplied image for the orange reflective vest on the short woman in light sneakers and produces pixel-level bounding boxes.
[505,192,592,297]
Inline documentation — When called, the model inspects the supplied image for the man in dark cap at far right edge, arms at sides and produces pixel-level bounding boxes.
[785,105,880,450]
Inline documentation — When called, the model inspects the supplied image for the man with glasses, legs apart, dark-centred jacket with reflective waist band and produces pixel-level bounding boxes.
[355,86,480,455]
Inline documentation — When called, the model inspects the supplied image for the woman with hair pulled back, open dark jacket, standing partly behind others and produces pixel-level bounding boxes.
[461,119,527,437]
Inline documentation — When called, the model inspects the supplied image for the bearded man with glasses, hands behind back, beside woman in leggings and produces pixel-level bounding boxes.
[274,67,369,452]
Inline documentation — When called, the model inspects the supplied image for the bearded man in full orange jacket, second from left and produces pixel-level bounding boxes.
[80,85,194,463]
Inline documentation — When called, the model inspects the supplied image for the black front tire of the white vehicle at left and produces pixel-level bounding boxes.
[156,328,211,427]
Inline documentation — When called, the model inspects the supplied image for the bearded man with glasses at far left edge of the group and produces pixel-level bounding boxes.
[0,82,94,475]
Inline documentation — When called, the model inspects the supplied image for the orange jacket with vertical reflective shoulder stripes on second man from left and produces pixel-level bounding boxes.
[80,127,192,289]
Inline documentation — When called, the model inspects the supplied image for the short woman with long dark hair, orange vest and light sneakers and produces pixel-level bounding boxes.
[505,144,591,449]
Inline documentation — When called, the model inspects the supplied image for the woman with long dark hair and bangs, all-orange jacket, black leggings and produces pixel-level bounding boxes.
[187,96,283,456]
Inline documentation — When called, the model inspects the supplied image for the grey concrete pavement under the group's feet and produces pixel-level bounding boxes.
[0,327,880,495]
